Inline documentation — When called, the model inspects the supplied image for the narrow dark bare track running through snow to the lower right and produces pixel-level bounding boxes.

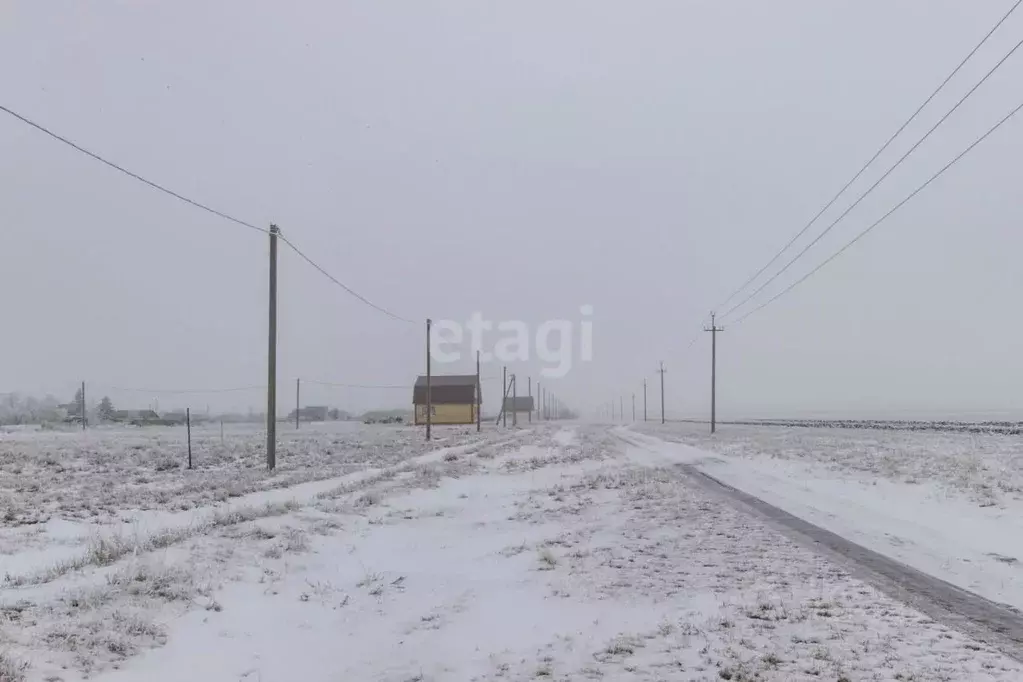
[616,433,1023,662]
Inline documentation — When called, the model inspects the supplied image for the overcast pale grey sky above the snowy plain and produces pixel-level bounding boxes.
[0,0,1023,416]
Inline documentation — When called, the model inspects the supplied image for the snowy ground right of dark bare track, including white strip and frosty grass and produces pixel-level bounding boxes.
[632,424,1023,608]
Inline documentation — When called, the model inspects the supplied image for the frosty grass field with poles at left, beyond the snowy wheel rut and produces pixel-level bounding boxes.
[0,422,493,526]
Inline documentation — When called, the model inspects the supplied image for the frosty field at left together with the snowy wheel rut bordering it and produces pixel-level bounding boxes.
[0,422,495,583]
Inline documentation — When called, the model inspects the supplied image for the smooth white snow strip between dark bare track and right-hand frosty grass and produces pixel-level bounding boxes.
[630,430,1023,609]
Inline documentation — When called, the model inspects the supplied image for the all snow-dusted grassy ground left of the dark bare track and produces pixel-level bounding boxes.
[0,424,1023,682]
